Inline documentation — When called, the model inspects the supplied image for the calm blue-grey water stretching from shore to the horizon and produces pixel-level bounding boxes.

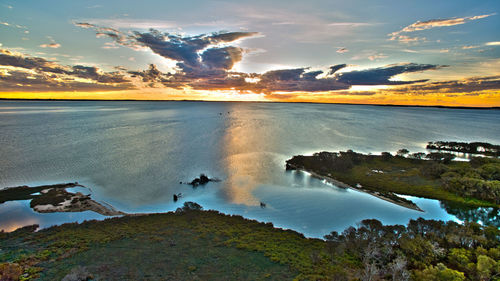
[0,101,500,237]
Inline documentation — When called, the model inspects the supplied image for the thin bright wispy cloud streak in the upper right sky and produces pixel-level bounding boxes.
[388,13,496,43]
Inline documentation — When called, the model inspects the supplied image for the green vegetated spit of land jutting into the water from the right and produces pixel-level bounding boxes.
[287,150,500,208]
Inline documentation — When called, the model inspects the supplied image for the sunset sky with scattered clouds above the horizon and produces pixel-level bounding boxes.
[0,0,500,107]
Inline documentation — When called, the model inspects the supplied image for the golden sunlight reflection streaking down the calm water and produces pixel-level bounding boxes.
[220,105,283,206]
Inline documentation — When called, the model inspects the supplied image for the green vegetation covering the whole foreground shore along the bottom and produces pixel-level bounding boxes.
[0,203,500,280]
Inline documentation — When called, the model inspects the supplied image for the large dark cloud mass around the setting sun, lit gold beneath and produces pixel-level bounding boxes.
[10,26,450,95]
